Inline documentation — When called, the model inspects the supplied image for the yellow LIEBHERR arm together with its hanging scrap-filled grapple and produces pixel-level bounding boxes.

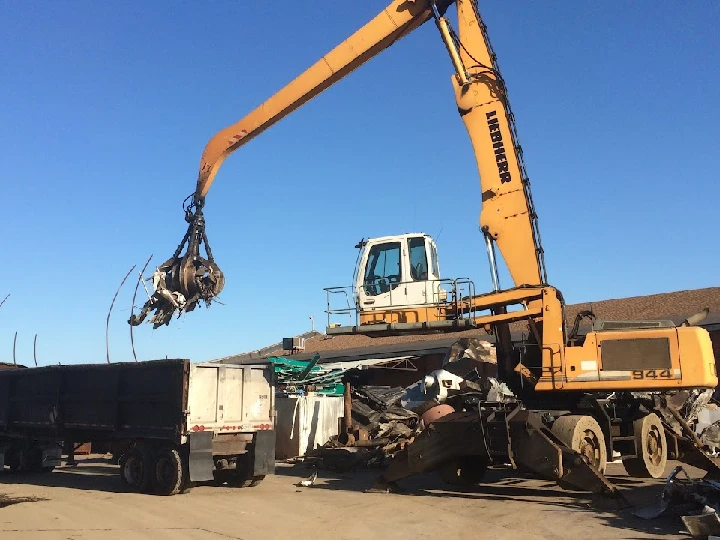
[130,0,547,327]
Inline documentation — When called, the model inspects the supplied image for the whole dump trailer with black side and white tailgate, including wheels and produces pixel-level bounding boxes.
[0,359,276,495]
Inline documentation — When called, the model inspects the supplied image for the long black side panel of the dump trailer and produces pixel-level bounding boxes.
[0,359,189,441]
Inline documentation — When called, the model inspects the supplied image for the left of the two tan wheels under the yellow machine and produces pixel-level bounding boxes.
[551,414,607,474]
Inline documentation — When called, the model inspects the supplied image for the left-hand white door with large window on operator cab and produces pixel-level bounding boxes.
[357,240,407,310]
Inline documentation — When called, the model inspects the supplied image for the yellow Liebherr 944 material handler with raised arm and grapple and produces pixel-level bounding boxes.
[129,0,718,492]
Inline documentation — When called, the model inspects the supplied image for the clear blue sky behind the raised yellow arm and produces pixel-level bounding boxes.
[0,0,720,364]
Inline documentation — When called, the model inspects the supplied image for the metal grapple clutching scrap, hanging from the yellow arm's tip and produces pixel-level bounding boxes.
[128,194,225,328]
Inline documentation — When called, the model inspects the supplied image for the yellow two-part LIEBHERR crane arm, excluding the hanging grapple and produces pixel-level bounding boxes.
[196,0,546,286]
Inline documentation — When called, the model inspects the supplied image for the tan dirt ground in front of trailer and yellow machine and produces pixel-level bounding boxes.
[0,456,701,540]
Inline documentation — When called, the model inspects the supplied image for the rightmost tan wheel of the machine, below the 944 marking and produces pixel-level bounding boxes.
[623,413,667,478]
